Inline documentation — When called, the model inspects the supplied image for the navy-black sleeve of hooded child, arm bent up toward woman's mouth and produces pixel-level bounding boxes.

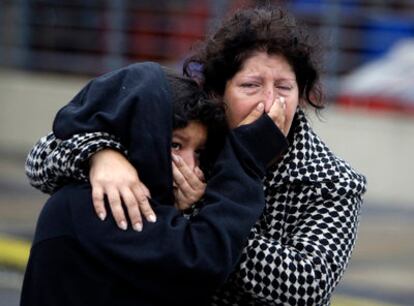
[63,116,287,305]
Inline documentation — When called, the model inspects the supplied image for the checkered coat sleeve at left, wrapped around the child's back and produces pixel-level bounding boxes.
[25,132,126,194]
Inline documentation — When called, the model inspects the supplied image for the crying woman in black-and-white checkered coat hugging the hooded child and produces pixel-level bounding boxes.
[25,7,366,305]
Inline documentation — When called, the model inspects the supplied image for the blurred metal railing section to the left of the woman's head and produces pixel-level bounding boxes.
[0,0,225,74]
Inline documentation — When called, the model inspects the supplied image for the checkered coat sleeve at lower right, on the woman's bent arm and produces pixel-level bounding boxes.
[223,180,362,305]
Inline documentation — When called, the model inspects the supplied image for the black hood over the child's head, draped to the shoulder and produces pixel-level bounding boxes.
[53,62,173,203]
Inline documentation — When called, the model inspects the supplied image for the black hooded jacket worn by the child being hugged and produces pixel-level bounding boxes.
[21,63,287,306]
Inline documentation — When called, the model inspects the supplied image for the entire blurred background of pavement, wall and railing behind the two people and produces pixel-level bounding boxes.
[0,0,414,306]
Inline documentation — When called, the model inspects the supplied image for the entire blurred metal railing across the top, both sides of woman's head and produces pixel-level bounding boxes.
[0,0,414,95]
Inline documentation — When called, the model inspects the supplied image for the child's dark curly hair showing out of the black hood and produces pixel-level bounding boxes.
[163,67,228,174]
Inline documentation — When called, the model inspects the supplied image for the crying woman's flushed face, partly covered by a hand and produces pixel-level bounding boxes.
[223,52,299,131]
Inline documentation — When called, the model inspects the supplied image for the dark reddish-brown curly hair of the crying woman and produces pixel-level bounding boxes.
[183,6,323,109]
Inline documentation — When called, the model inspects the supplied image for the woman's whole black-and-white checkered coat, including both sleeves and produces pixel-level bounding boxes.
[26,110,366,306]
